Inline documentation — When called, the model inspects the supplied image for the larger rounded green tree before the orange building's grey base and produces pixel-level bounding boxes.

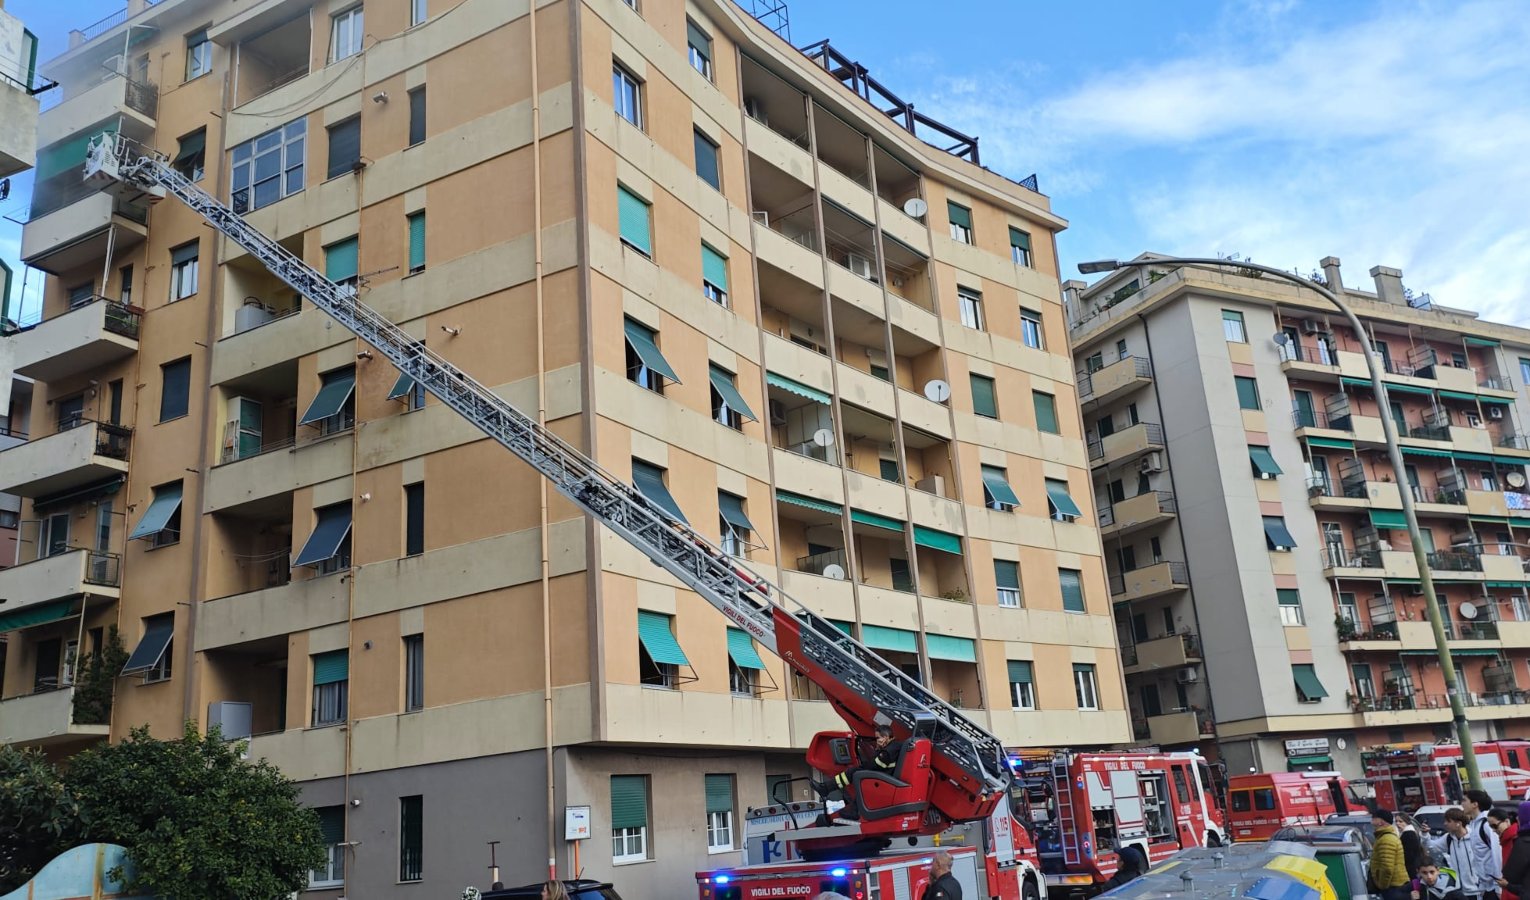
[69,722,324,900]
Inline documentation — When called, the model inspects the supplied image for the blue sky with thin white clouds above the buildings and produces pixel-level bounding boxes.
[0,0,1530,326]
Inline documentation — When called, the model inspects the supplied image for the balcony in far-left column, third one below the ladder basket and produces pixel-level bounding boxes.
[0,418,133,497]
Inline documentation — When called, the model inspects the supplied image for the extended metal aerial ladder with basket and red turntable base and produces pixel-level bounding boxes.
[84,133,1013,851]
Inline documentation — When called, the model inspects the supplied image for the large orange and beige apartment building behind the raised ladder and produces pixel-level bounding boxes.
[0,0,1128,900]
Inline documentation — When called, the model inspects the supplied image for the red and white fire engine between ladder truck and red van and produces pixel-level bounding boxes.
[1010,750,1227,894]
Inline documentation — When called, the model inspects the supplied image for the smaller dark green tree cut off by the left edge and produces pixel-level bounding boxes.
[0,745,80,894]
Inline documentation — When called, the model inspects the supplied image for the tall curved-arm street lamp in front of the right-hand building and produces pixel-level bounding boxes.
[1079,257,1483,788]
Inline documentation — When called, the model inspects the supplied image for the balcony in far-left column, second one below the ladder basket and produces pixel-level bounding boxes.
[11,297,141,381]
